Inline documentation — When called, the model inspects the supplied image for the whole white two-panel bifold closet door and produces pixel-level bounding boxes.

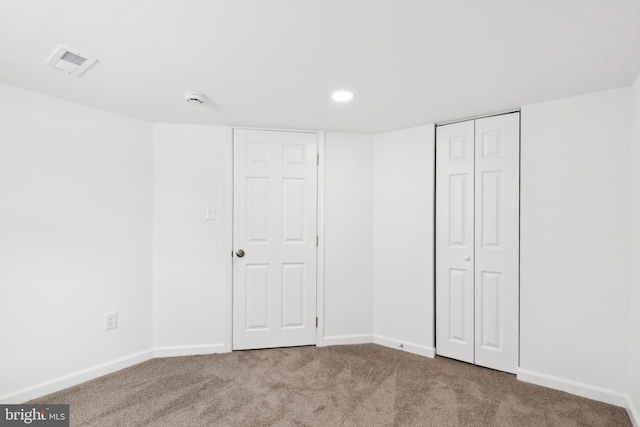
[436,113,520,373]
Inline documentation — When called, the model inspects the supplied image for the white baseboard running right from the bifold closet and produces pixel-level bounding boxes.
[516,369,629,408]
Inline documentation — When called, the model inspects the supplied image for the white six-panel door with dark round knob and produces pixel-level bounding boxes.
[233,129,318,350]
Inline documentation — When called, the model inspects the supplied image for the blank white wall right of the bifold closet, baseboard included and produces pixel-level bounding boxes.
[518,88,631,404]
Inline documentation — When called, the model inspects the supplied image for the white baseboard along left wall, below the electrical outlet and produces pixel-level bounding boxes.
[0,350,153,404]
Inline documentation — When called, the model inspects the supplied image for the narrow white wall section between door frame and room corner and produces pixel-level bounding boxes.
[324,132,373,345]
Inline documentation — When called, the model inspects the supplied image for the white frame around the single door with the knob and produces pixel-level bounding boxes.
[222,126,325,352]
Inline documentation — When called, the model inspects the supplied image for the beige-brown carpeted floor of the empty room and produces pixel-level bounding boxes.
[31,344,631,427]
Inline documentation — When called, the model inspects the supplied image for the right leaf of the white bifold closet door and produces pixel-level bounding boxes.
[475,113,520,373]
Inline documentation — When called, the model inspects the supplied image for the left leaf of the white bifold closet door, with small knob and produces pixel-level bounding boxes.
[436,121,474,363]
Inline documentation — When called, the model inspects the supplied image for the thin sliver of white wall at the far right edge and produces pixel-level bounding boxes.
[627,76,640,425]
